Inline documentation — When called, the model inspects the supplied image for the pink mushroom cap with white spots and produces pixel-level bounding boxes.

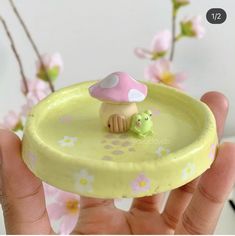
[89,72,148,103]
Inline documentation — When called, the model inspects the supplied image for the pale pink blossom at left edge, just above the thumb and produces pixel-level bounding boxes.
[0,111,23,131]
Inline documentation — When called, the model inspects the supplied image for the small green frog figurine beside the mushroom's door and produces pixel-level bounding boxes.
[130,110,153,138]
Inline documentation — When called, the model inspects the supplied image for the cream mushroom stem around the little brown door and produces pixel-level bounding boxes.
[100,102,138,133]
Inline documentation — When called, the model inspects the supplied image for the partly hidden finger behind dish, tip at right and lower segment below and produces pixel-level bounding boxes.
[162,92,228,229]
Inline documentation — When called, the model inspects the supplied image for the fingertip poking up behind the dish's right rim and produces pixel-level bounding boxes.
[201,92,229,138]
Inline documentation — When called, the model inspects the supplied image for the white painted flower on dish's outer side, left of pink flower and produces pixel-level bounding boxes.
[76,169,94,193]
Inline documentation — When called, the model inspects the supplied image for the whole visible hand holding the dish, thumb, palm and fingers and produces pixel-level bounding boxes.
[0,92,235,234]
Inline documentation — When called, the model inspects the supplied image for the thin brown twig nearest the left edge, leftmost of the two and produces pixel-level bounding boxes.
[0,16,29,94]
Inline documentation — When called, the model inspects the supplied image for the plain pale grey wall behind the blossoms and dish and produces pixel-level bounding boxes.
[0,0,235,234]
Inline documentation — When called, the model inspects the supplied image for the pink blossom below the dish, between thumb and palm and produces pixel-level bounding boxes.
[47,191,80,235]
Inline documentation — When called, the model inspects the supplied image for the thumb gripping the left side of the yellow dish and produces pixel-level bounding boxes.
[0,130,52,234]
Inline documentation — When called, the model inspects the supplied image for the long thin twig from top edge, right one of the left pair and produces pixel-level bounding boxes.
[9,0,55,92]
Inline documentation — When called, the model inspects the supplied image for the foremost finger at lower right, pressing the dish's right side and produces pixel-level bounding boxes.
[176,143,235,234]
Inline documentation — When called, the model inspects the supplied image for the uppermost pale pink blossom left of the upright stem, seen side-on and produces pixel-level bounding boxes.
[135,30,172,60]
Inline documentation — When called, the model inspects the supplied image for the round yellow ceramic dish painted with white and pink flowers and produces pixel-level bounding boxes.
[23,82,217,198]
